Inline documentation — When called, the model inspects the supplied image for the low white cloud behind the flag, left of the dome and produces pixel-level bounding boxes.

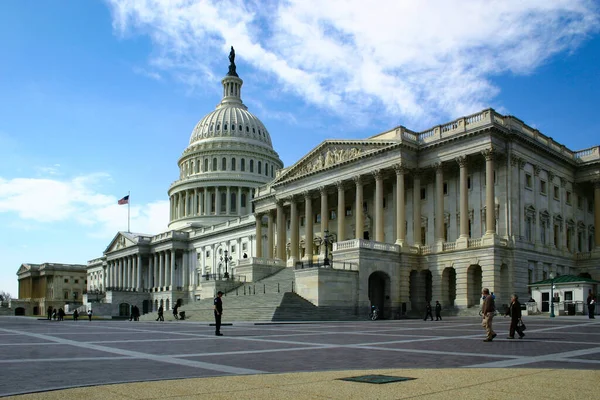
[0,173,169,238]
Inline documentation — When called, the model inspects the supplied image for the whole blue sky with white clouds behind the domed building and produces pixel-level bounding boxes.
[0,0,600,296]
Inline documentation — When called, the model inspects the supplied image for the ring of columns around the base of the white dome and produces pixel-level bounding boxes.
[170,186,254,221]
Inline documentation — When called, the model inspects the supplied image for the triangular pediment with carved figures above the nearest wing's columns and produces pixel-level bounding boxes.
[274,140,398,184]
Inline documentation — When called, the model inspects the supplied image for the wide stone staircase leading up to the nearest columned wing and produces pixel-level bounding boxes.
[140,268,358,322]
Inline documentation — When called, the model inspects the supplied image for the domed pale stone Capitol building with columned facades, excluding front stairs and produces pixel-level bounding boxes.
[84,49,600,316]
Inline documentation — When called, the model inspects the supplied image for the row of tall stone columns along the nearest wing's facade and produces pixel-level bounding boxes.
[256,149,500,260]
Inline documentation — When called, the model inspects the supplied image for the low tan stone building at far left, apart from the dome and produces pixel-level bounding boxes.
[11,263,87,315]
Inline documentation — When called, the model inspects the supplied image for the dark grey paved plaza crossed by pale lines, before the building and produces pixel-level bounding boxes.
[0,317,600,398]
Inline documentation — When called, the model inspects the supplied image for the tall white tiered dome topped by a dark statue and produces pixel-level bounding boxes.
[169,48,283,229]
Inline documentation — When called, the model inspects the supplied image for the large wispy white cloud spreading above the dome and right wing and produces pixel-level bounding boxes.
[108,0,599,124]
